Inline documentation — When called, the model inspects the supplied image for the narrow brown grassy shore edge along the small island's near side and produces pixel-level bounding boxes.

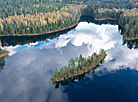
[50,53,107,82]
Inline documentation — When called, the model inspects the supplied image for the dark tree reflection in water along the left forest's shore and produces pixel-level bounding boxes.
[0,26,76,46]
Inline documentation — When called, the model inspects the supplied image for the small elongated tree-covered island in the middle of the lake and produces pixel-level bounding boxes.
[51,49,107,82]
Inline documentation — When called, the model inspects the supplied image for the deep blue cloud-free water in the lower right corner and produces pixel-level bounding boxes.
[68,69,138,102]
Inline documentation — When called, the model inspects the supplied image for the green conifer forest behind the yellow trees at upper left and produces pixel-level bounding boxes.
[0,0,67,18]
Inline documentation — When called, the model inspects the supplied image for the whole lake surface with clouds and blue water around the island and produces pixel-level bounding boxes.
[0,22,138,102]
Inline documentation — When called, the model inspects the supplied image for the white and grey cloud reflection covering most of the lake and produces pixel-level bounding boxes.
[0,22,138,102]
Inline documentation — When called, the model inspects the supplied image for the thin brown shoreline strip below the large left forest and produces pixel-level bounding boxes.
[0,20,79,37]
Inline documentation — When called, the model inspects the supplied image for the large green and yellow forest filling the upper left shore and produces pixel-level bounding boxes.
[0,0,86,35]
